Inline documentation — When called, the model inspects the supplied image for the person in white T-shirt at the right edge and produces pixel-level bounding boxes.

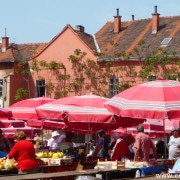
[168,127,180,160]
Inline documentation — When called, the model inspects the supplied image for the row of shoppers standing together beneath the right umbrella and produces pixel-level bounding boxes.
[85,124,180,162]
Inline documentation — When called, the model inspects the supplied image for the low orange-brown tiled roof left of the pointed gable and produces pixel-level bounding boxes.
[0,43,47,62]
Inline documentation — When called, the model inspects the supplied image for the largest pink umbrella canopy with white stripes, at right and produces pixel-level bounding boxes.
[104,79,180,120]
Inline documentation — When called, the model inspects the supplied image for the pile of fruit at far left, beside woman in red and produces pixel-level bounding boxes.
[0,157,17,170]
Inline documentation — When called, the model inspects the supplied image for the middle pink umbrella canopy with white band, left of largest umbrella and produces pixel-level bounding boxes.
[36,95,116,123]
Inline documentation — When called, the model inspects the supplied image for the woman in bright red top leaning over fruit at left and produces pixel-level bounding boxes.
[7,131,39,174]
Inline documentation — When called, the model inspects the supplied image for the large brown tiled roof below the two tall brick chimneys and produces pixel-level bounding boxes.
[95,16,180,57]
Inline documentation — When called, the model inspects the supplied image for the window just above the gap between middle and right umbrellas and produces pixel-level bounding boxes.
[109,78,119,97]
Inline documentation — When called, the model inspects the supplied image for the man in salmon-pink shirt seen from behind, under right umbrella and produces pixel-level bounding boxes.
[133,124,157,162]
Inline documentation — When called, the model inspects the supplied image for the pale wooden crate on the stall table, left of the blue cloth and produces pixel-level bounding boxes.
[97,160,125,170]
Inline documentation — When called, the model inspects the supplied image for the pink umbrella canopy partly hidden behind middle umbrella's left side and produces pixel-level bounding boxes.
[9,97,55,120]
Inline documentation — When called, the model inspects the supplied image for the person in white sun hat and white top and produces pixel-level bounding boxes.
[47,131,60,150]
